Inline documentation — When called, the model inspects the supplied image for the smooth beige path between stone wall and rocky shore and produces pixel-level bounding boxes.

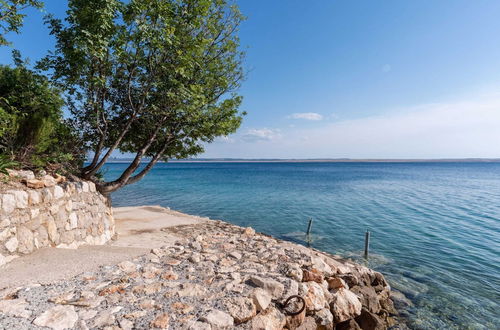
[0,206,206,289]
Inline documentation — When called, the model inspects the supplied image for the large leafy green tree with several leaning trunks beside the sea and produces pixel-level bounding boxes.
[42,0,244,194]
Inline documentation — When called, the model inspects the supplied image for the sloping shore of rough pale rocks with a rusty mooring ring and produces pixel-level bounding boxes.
[0,213,398,329]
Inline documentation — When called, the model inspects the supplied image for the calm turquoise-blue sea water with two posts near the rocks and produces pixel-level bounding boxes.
[106,163,500,329]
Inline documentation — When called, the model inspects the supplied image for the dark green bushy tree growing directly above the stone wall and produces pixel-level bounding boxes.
[0,62,83,170]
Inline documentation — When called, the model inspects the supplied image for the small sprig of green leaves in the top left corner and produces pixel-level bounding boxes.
[0,0,43,46]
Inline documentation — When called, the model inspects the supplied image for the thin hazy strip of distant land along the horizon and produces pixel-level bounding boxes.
[103,158,500,163]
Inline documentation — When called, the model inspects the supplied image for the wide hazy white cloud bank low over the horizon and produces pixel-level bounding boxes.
[203,95,500,158]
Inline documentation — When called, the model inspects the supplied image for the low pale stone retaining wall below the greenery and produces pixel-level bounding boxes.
[0,172,115,265]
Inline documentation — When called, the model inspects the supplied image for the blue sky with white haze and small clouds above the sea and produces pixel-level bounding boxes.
[0,0,500,158]
